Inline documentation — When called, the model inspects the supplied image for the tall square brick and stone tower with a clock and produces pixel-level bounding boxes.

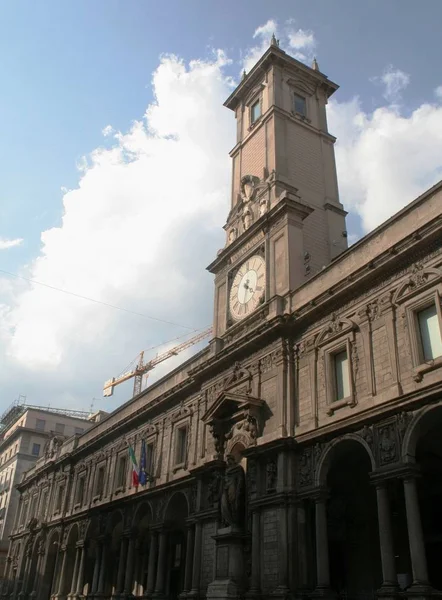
[208,36,347,338]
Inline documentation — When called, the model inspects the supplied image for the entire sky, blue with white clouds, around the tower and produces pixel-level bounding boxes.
[0,0,442,413]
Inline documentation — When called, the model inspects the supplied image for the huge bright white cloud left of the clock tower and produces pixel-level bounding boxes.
[3,52,234,384]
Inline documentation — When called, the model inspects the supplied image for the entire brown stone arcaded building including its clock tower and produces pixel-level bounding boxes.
[2,40,442,600]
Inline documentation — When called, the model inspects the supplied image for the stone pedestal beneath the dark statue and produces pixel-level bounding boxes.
[207,527,246,600]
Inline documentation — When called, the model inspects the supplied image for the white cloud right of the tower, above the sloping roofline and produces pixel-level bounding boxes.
[328,98,442,232]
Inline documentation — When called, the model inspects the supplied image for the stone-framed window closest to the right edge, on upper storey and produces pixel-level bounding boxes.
[403,289,442,381]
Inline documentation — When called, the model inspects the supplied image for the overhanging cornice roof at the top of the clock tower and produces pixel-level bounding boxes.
[224,44,339,110]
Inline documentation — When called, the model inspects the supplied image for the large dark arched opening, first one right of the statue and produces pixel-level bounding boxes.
[326,439,382,599]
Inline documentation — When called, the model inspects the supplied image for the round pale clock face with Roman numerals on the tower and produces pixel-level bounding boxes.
[229,254,266,320]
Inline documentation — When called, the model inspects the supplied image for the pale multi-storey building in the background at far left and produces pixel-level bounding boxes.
[0,398,97,575]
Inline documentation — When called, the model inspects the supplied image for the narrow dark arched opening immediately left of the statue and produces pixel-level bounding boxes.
[164,492,189,600]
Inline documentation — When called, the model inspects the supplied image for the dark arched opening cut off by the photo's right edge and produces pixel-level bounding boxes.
[415,406,442,590]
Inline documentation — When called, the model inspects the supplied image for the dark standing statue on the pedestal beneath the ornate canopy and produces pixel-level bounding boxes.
[221,454,245,527]
